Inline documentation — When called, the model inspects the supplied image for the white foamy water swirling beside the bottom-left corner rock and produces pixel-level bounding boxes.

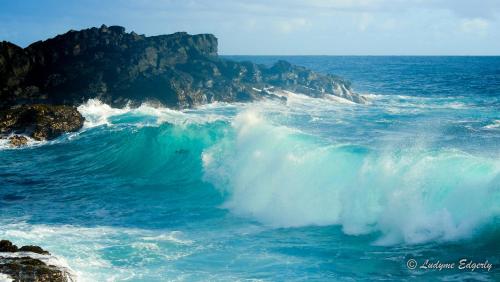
[0,222,196,282]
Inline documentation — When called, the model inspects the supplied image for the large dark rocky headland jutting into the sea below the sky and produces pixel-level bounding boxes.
[0,25,364,108]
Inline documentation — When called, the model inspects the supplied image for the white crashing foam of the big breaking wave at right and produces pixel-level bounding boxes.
[203,110,500,244]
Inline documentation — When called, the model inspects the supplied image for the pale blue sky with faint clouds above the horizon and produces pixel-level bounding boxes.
[0,0,500,55]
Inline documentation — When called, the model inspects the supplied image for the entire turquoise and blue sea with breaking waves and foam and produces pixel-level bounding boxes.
[0,57,500,281]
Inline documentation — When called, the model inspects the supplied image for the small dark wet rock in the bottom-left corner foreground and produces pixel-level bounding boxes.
[0,240,72,282]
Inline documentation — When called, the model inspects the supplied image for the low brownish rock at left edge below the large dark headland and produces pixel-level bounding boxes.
[0,104,84,140]
